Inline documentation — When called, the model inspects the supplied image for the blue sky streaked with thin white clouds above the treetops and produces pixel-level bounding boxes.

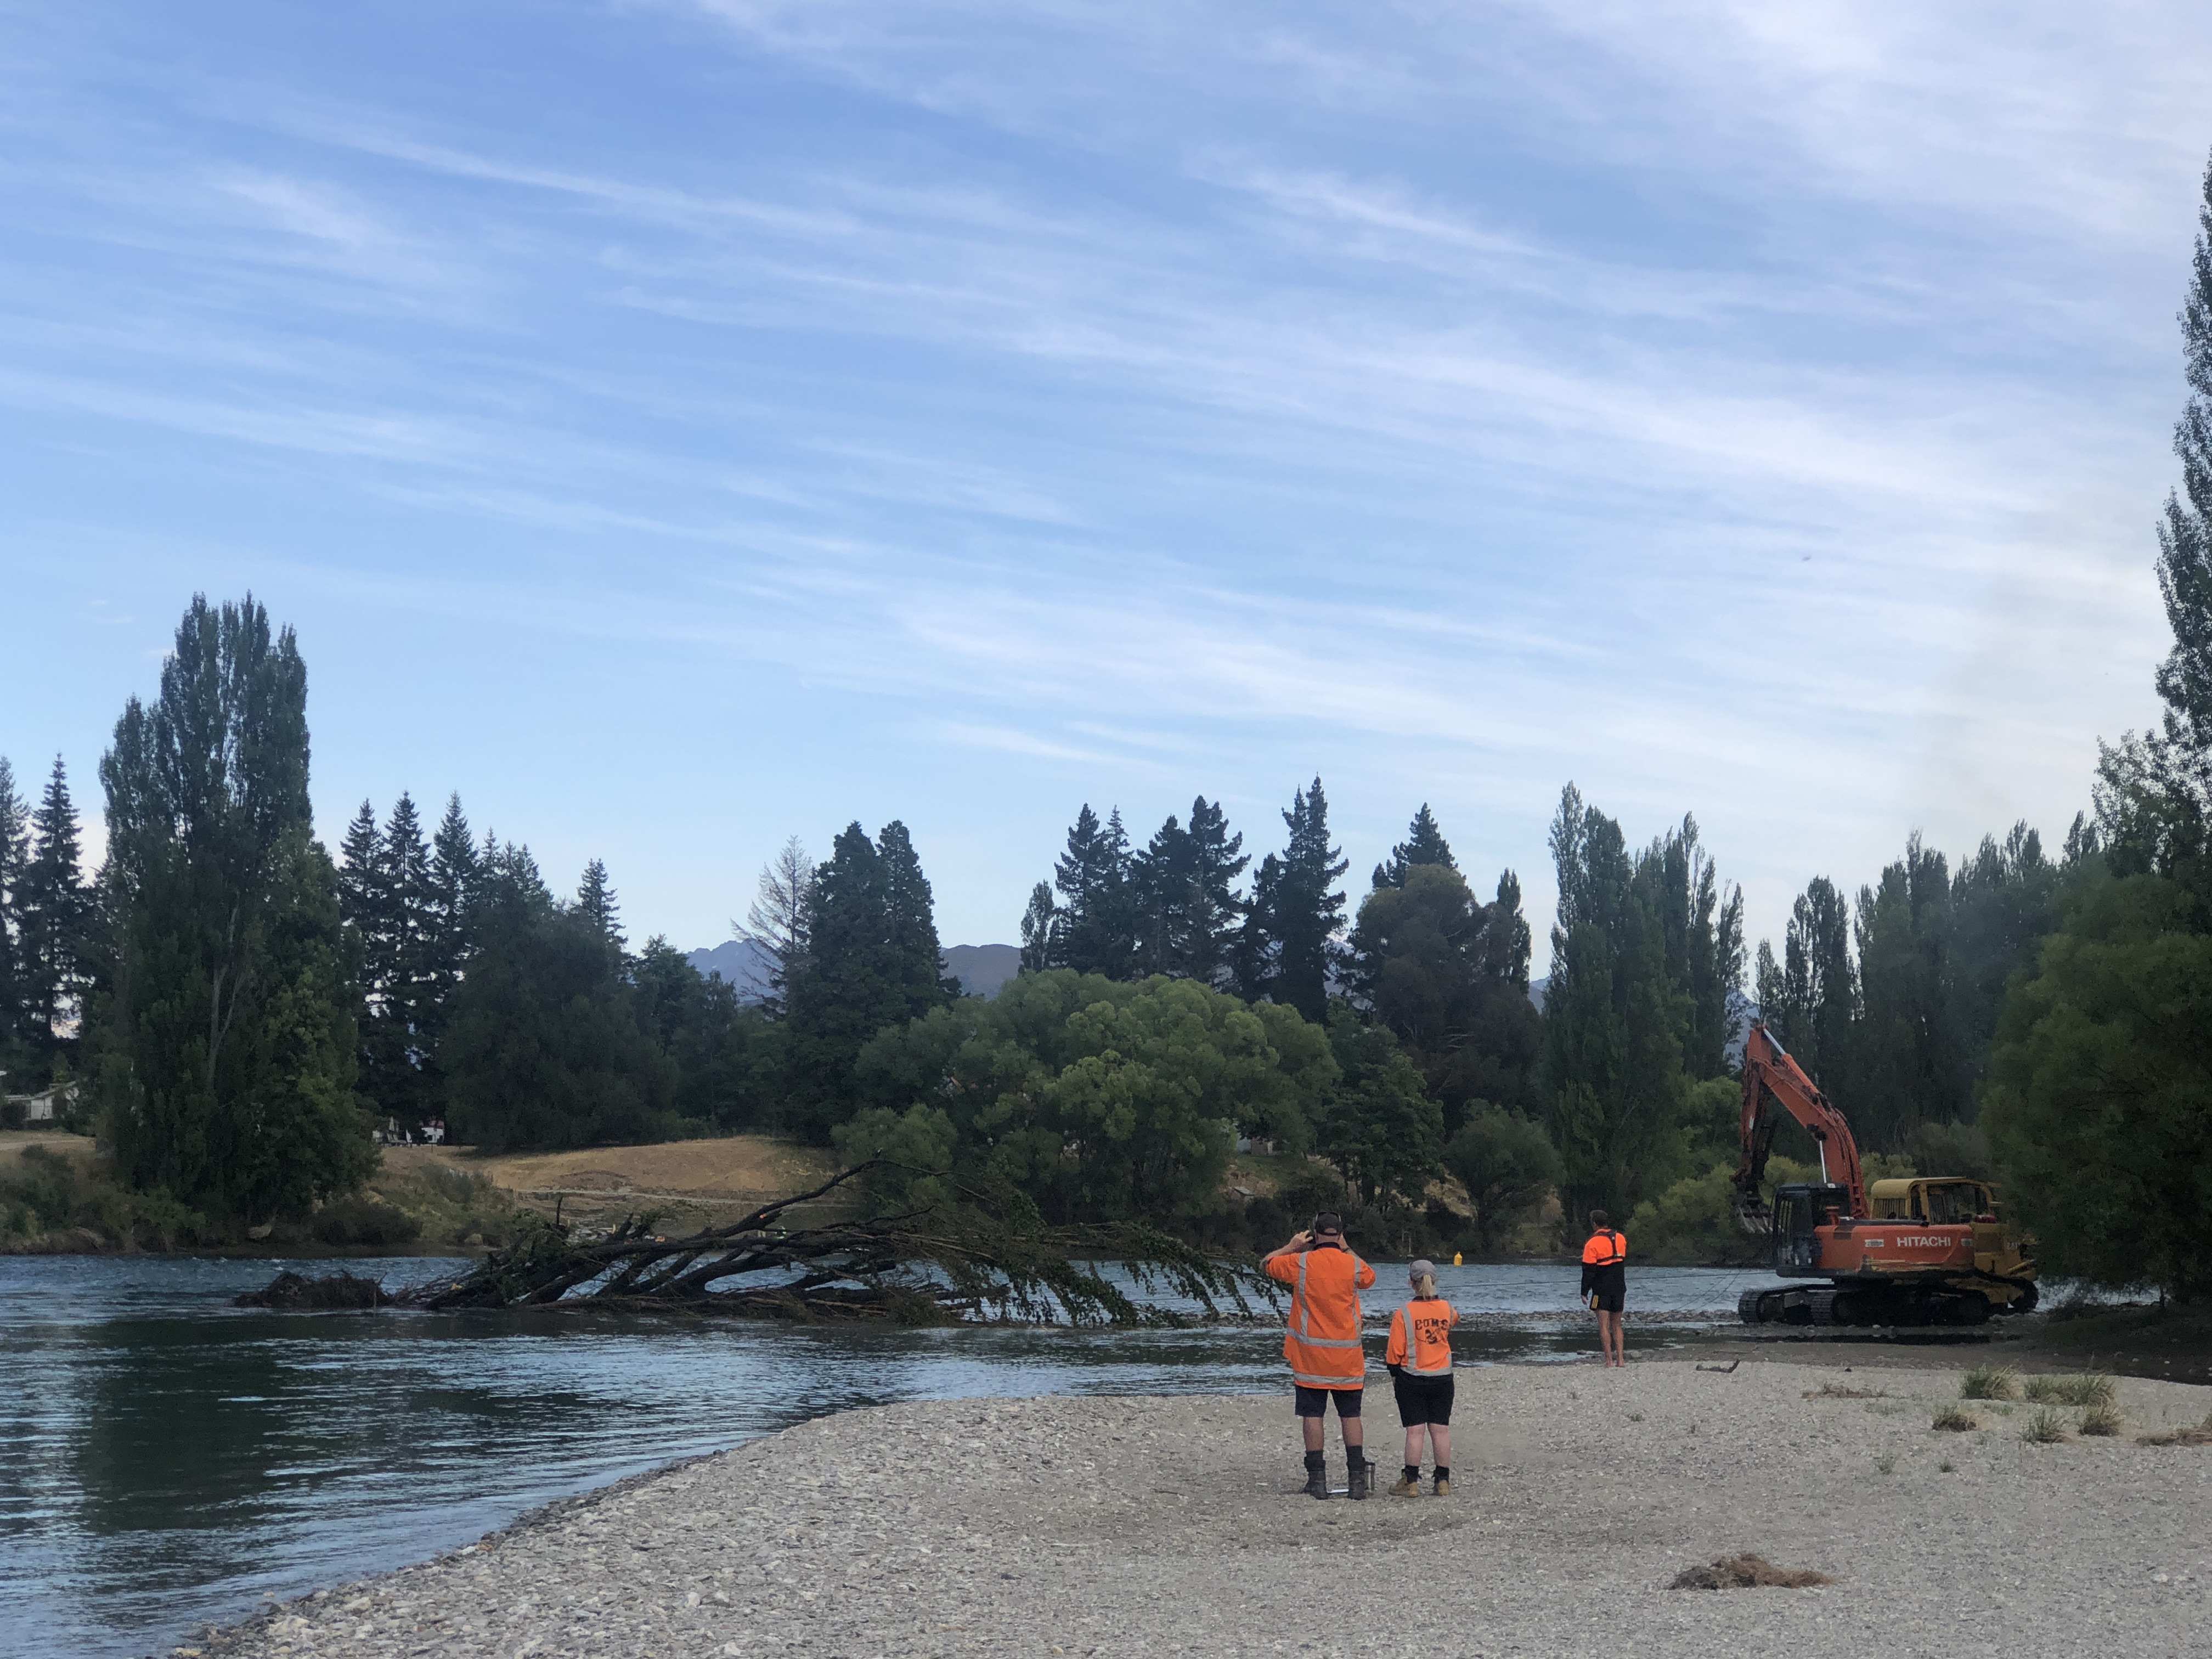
[0,0,2212,967]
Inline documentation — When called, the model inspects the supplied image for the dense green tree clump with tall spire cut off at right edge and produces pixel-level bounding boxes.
[1987,166,2212,1299]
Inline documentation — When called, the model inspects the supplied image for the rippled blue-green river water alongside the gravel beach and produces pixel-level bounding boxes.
[0,1256,1772,1659]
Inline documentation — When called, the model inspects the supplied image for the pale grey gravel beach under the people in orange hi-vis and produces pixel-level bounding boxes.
[194,1361,2212,1659]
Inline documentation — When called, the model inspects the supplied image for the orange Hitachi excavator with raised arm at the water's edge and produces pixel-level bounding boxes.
[1734,1022,2035,1325]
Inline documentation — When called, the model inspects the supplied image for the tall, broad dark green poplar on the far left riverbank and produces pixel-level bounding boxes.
[93,595,374,1221]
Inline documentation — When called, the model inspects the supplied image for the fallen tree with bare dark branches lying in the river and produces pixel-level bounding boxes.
[239,1159,1274,1325]
